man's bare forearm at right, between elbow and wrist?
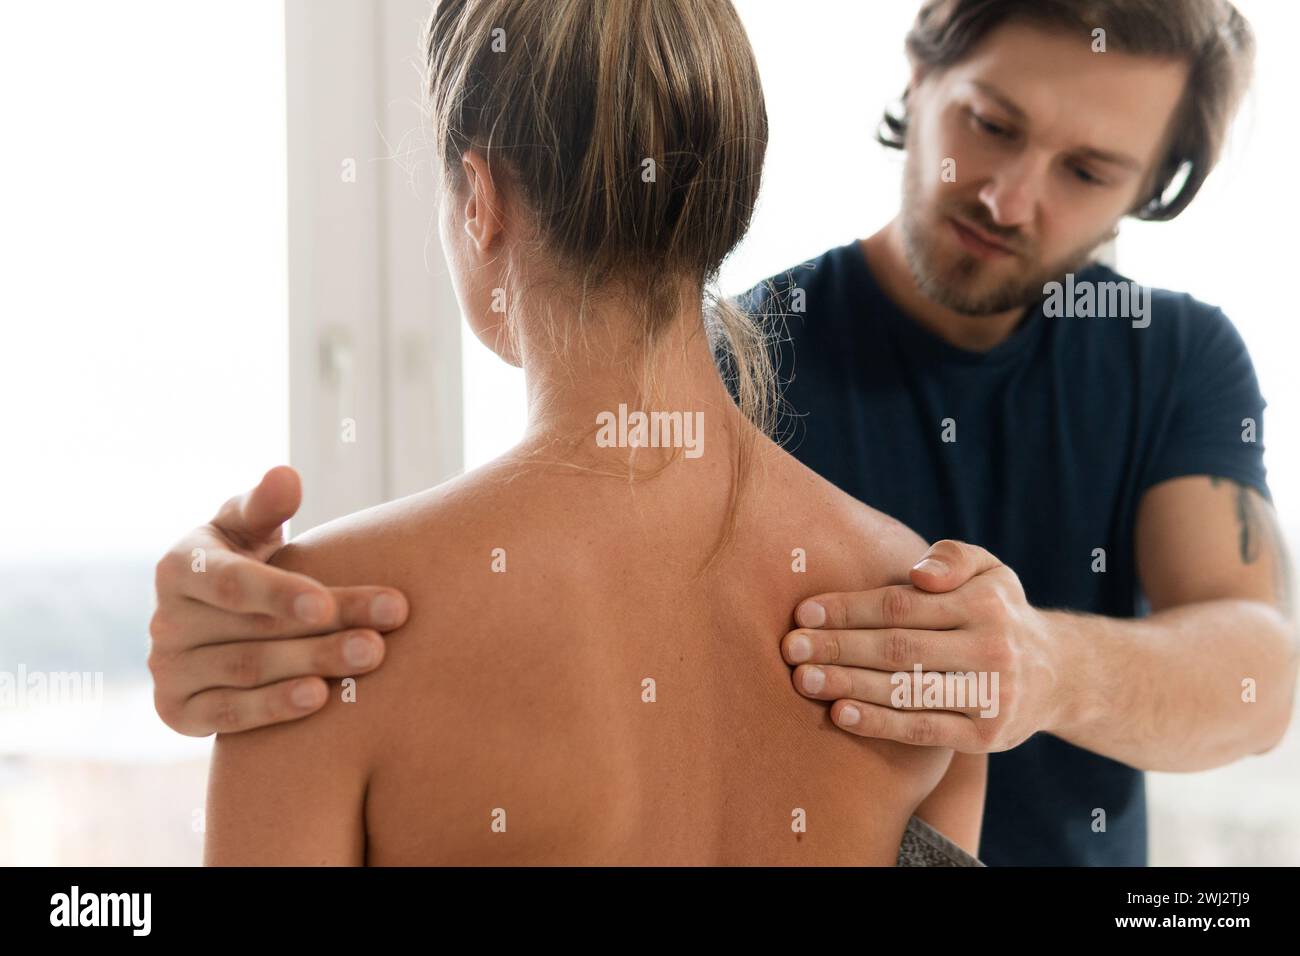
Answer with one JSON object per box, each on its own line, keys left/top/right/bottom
{"left": 1043, "top": 600, "right": 1297, "bottom": 771}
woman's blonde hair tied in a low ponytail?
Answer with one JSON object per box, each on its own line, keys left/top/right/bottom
{"left": 423, "top": 0, "right": 776, "bottom": 564}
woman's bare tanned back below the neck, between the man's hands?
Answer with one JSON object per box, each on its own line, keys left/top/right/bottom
{"left": 277, "top": 437, "right": 952, "bottom": 865}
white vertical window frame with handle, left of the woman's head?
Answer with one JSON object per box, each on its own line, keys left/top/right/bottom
{"left": 285, "top": 0, "right": 463, "bottom": 532}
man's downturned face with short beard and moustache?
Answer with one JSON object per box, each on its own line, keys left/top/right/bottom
{"left": 902, "top": 23, "right": 1187, "bottom": 315}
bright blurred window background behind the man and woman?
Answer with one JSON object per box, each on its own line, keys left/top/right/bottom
{"left": 0, "top": 0, "right": 1300, "bottom": 865}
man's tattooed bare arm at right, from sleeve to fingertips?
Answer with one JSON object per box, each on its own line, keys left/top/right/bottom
{"left": 783, "top": 476, "right": 1297, "bottom": 771}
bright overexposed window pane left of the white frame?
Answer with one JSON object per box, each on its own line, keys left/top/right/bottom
{"left": 0, "top": 0, "right": 289, "bottom": 865}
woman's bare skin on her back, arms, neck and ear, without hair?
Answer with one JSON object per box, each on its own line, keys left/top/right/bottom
{"left": 205, "top": 143, "right": 984, "bottom": 865}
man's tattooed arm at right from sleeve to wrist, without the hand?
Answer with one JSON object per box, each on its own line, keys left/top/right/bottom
{"left": 1044, "top": 476, "right": 1297, "bottom": 771}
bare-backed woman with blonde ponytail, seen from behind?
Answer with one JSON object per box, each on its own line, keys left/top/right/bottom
{"left": 205, "top": 0, "right": 983, "bottom": 865}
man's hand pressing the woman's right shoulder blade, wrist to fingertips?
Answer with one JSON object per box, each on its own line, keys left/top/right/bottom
{"left": 781, "top": 540, "right": 1063, "bottom": 753}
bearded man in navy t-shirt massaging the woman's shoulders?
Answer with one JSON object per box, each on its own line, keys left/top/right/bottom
{"left": 151, "top": 0, "right": 1296, "bottom": 865}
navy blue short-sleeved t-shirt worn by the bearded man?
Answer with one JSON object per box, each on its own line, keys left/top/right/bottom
{"left": 738, "top": 242, "right": 1271, "bottom": 866}
